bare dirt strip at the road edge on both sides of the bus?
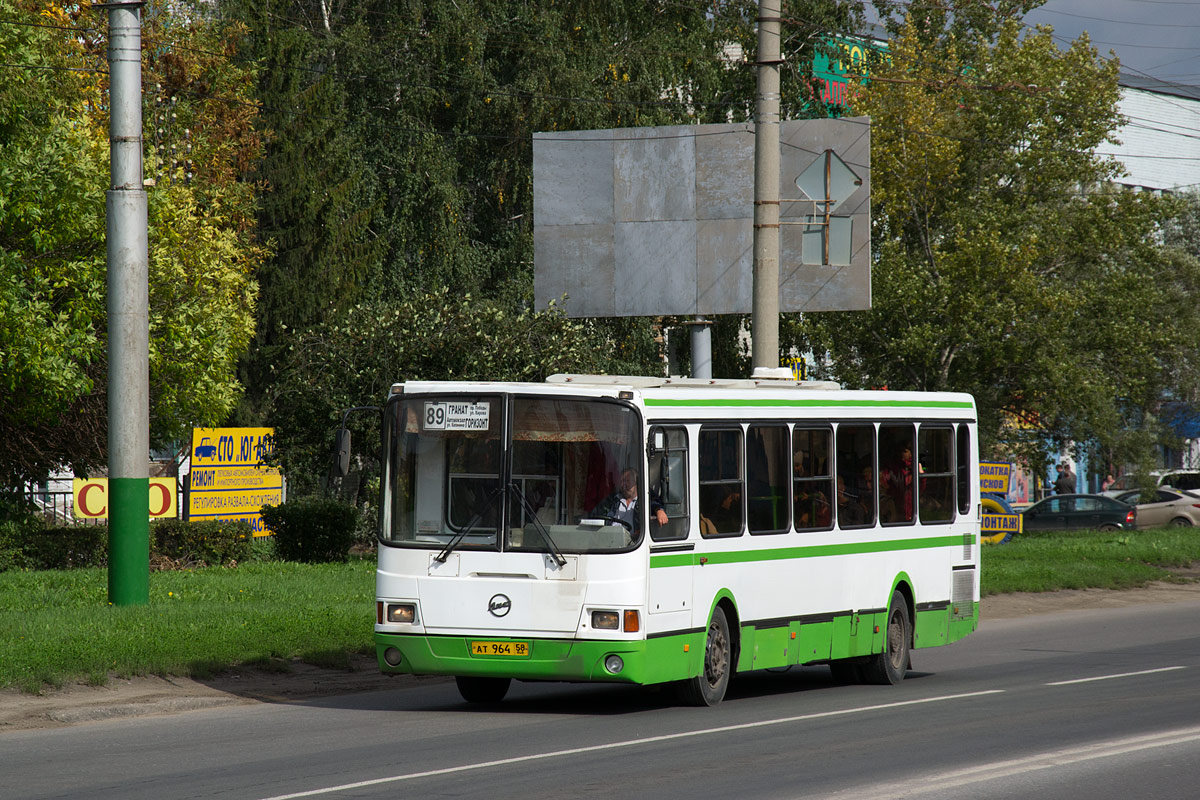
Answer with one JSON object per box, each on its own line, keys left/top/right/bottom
{"left": 7, "top": 573, "right": 1200, "bottom": 735}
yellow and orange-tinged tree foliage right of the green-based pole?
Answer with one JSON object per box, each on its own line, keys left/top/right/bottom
{"left": 143, "top": 2, "right": 270, "bottom": 445}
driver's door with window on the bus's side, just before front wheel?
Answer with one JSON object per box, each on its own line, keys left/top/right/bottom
{"left": 647, "top": 426, "right": 695, "bottom": 627}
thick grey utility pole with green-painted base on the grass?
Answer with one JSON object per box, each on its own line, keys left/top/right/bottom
{"left": 102, "top": 0, "right": 150, "bottom": 606}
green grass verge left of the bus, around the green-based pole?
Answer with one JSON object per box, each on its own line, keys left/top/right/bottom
{"left": 0, "top": 559, "right": 374, "bottom": 692}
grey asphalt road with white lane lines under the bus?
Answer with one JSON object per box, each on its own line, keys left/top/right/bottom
{"left": 0, "top": 601, "right": 1200, "bottom": 800}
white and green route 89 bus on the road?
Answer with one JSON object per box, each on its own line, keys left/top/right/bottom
{"left": 374, "top": 375, "right": 980, "bottom": 705}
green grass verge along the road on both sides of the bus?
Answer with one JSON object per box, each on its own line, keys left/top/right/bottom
{"left": 0, "top": 528, "right": 1200, "bottom": 692}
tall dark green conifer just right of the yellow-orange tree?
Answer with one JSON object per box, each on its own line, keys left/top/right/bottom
{"left": 222, "top": 0, "right": 383, "bottom": 425}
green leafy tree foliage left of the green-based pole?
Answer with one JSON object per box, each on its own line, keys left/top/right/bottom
{"left": 0, "top": 0, "right": 107, "bottom": 483}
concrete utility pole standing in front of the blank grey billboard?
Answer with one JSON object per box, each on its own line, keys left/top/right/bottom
{"left": 750, "top": 0, "right": 782, "bottom": 369}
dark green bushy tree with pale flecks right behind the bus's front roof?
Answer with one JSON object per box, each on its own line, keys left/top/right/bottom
{"left": 270, "top": 288, "right": 641, "bottom": 492}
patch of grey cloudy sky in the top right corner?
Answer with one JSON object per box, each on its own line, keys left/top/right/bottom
{"left": 1025, "top": 0, "right": 1200, "bottom": 86}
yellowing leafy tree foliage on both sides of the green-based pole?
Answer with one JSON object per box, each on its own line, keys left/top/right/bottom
{"left": 0, "top": 0, "right": 260, "bottom": 482}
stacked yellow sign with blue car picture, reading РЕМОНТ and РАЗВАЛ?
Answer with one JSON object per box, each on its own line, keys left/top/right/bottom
{"left": 187, "top": 428, "right": 283, "bottom": 536}
